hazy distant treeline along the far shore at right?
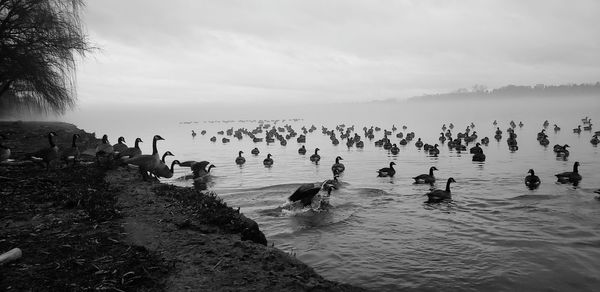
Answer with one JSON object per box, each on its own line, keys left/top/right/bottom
{"left": 411, "top": 82, "right": 600, "bottom": 100}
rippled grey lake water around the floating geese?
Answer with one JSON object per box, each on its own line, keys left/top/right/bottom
{"left": 67, "top": 98, "right": 600, "bottom": 291}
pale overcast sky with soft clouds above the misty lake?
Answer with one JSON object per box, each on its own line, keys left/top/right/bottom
{"left": 77, "top": 0, "right": 600, "bottom": 106}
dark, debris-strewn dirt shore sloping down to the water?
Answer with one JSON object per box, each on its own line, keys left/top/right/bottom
{"left": 0, "top": 122, "right": 364, "bottom": 291}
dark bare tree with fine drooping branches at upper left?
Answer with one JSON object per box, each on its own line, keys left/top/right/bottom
{"left": 0, "top": 0, "right": 91, "bottom": 116}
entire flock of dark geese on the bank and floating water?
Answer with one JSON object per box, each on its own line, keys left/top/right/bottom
{"left": 0, "top": 117, "right": 600, "bottom": 206}
